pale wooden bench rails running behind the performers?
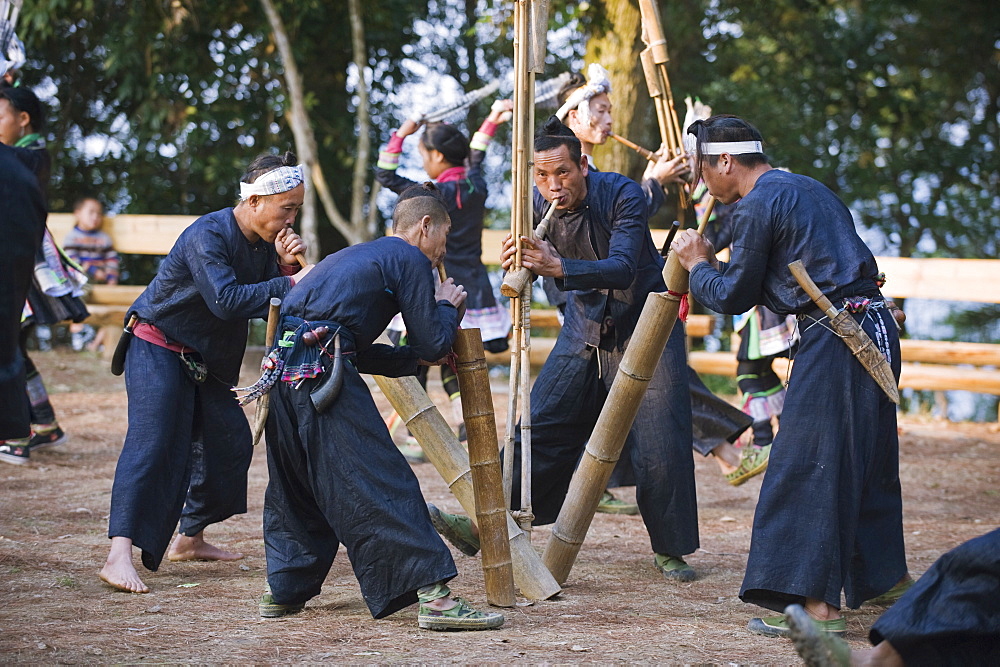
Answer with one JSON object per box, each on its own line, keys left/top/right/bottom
{"left": 49, "top": 213, "right": 1000, "bottom": 404}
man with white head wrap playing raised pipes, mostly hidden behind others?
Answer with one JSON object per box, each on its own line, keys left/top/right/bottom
{"left": 543, "top": 68, "right": 752, "bottom": 498}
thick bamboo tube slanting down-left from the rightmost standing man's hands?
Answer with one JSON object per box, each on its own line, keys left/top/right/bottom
{"left": 542, "top": 200, "right": 711, "bottom": 584}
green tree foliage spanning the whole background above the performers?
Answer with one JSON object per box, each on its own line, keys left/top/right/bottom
{"left": 18, "top": 0, "right": 1000, "bottom": 257}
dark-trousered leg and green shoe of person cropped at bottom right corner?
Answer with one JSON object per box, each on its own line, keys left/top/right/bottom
{"left": 785, "top": 530, "right": 1000, "bottom": 667}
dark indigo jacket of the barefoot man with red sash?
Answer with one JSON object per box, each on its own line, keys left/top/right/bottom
{"left": 129, "top": 208, "right": 292, "bottom": 386}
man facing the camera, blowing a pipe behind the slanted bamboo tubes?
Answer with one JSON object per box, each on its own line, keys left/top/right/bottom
{"left": 431, "top": 117, "right": 698, "bottom": 581}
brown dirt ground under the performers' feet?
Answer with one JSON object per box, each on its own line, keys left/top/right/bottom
{"left": 0, "top": 351, "right": 1000, "bottom": 664}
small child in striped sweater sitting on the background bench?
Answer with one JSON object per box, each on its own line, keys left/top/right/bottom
{"left": 63, "top": 197, "right": 119, "bottom": 352}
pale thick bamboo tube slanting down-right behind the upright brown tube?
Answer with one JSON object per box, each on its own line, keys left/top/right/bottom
{"left": 375, "top": 375, "right": 561, "bottom": 600}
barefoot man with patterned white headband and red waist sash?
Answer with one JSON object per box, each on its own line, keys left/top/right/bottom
{"left": 100, "top": 153, "right": 311, "bottom": 593}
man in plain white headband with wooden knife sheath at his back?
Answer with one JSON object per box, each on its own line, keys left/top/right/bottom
{"left": 671, "top": 116, "right": 912, "bottom": 636}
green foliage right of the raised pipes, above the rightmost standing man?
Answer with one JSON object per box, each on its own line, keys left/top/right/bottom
{"left": 705, "top": 0, "right": 1000, "bottom": 257}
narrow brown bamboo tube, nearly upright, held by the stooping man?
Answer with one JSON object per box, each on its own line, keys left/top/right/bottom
{"left": 455, "top": 329, "right": 514, "bottom": 607}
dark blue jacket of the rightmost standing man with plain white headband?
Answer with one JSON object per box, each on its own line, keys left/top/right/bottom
{"left": 691, "top": 169, "right": 878, "bottom": 315}
